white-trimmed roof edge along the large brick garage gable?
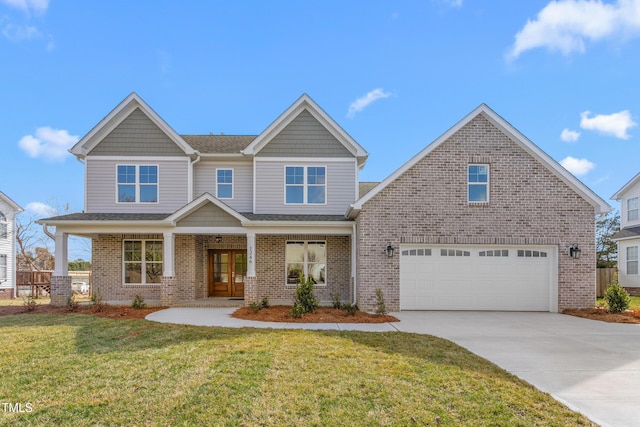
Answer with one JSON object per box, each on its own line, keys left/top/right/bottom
{"left": 348, "top": 104, "right": 611, "bottom": 216}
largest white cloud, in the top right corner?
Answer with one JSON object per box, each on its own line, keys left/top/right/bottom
{"left": 507, "top": 0, "right": 640, "bottom": 60}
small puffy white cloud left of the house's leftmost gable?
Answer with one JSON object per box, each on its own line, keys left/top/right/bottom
{"left": 18, "top": 126, "right": 79, "bottom": 161}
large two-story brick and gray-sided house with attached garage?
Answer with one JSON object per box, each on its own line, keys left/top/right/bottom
{"left": 41, "top": 93, "right": 610, "bottom": 311}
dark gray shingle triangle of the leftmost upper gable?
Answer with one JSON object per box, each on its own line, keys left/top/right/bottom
{"left": 89, "top": 108, "right": 184, "bottom": 156}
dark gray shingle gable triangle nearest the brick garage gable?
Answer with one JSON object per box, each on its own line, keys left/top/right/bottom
{"left": 256, "top": 110, "right": 353, "bottom": 157}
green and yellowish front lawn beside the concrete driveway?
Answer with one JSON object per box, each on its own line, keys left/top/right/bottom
{"left": 0, "top": 314, "right": 592, "bottom": 426}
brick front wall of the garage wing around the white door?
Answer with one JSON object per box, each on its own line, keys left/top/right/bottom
{"left": 356, "top": 116, "right": 595, "bottom": 311}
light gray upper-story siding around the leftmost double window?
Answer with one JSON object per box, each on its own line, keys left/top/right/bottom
{"left": 85, "top": 157, "right": 189, "bottom": 213}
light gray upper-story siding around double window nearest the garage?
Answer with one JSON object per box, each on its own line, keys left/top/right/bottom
{"left": 255, "top": 158, "right": 358, "bottom": 215}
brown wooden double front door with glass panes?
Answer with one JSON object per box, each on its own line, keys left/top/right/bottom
{"left": 209, "top": 249, "right": 247, "bottom": 298}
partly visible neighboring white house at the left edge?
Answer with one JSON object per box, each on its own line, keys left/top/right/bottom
{"left": 0, "top": 191, "right": 23, "bottom": 299}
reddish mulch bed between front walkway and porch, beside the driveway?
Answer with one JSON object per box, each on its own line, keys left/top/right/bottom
{"left": 231, "top": 305, "right": 399, "bottom": 323}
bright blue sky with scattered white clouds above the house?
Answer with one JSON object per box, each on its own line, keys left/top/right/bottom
{"left": 0, "top": 0, "right": 640, "bottom": 259}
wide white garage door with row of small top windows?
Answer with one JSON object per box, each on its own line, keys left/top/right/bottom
{"left": 400, "top": 245, "right": 557, "bottom": 311}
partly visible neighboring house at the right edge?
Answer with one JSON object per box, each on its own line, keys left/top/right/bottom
{"left": 611, "top": 173, "right": 640, "bottom": 296}
